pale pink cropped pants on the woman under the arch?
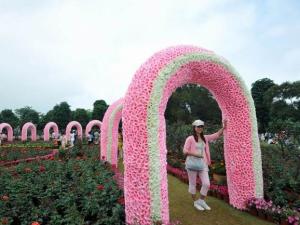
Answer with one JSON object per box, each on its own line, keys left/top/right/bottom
{"left": 187, "top": 170, "right": 210, "bottom": 196}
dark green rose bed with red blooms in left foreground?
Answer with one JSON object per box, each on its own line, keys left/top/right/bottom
{"left": 0, "top": 145, "right": 125, "bottom": 225}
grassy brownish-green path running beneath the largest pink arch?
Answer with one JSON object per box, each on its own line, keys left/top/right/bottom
{"left": 118, "top": 162, "right": 272, "bottom": 225}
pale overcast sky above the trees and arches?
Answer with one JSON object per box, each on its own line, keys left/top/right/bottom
{"left": 0, "top": 0, "right": 300, "bottom": 113}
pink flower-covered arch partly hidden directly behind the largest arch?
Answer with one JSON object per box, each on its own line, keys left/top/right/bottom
{"left": 100, "top": 98, "right": 123, "bottom": 166}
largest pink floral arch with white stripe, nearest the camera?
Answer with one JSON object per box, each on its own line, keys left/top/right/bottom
{"left": 122, "top": 46, "right": 263, "bottom": 224}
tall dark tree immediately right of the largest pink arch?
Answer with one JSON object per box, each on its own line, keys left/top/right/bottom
{"left": 251, "top": 78, "right": 275, "bottom": 133}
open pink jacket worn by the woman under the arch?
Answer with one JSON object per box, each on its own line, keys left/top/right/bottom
{"left": 183, "top": 132, "right": 222, "bottom": 165}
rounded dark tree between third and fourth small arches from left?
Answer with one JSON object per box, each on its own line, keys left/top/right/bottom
{"left": 51, "top": 102, "right": 72, "bottom": 130}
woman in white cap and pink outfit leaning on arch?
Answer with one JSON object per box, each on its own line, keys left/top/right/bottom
{"left": 183, "top": 120, "right": 226, "bottom": 210}
